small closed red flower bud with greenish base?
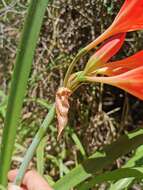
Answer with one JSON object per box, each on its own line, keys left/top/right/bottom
{"left": 85, "top": 33, "right": 126, "bottom": 73}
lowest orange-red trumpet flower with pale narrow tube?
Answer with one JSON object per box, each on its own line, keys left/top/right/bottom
{"left": 86, "top": 66, "right": 143, "bottom": 100}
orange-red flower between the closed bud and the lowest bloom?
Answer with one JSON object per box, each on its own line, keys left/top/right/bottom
{"left": 97, "top": 51, "right": 143, "bottom": 76}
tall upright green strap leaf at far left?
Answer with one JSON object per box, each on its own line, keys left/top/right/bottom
{"left": 0, "top": 0, "right": 48, "bottom": 186}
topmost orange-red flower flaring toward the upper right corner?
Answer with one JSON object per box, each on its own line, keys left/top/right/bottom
{"left": 84, "top": 0, "right": 143, "bottom": 51}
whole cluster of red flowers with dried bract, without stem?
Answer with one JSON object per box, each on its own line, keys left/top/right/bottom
{"left": 56, "top": 0, "right": 143, "bottom": 137}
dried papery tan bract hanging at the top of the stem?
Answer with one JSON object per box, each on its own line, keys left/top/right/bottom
{"left": 55, "top": 87, "right": 72, "bottom": 139}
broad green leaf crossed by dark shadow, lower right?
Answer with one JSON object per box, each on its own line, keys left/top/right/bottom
{"left": 53, "top": 129, "right": 143, "bottom": 190}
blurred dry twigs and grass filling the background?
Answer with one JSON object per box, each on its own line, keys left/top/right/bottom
{"left": 0, "top": 0, "right": 143, "bottom": 190}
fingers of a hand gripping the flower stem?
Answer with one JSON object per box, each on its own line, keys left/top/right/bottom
{"left": 8, "top": 170, "right": 53, "bottom": 190}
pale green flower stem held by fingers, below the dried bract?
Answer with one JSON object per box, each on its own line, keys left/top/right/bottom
{"left": 14, "top": 104, "right": 55, "bottom": 185}
